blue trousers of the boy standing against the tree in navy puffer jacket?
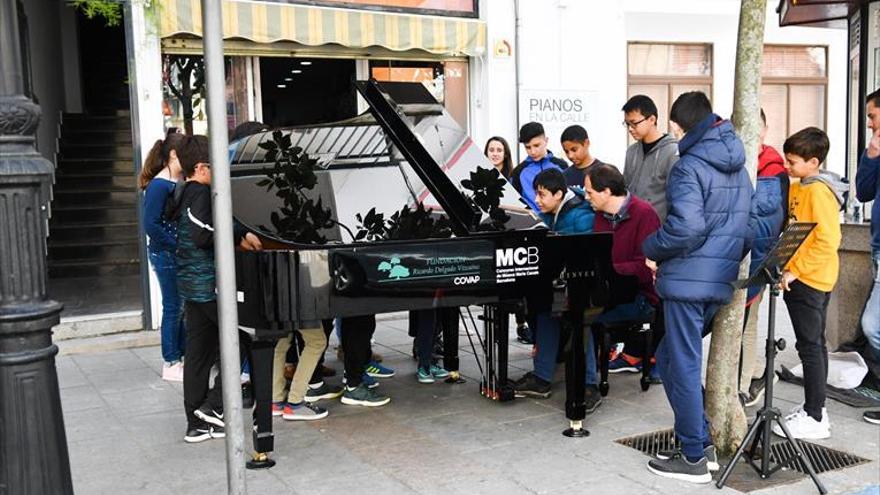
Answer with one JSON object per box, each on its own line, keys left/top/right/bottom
{"left": 655, "top": 300, "right": 721, "bottom": 459}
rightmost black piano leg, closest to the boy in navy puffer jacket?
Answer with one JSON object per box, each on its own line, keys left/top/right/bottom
{"left": 562, "top": 308, "right": 590, "bottom": 438}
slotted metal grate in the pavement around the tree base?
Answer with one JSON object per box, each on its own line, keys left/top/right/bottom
{"left": 615, "top": 429, "right": 870, "bottom": 474}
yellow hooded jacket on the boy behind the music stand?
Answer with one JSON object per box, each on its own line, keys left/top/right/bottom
{"left": 785, "top": 170, "right": 847, "bottom": 292}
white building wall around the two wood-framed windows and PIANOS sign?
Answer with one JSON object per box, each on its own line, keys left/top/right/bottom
{"left": 471, "top": 0, "right": 847, "bottom": 173}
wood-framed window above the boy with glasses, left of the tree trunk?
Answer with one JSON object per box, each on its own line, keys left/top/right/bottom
{"left": 627, "top": 42, "right": 712, "bottom": 139}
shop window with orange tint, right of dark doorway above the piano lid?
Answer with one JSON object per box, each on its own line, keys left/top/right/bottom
{"left": 370, "top": 60, "right": 468, "bottom": 131}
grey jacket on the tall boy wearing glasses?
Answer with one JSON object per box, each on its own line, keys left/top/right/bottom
{"left": 623, "top": 134, "right": 678, "bottom": 222}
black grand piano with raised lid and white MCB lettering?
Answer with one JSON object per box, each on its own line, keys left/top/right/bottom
{"left": 231, "top": 80, "right": 613, "bottom": 467}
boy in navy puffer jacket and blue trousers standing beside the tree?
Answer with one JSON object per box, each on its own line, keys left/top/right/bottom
{"left": 642, "top": 91, "right": 752, "bottom": 483}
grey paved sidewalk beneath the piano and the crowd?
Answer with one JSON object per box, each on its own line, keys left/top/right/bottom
{"left": 57, "top": 302, "right": 880, "bottom": 495}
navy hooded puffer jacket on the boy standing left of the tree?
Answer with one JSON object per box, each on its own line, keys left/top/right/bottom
{"left": 642, "top": 114, "right": 752, "bottom": 303}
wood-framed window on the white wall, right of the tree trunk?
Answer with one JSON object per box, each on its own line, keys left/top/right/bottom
{"left": 761, "top": 45, "right": 828, "bottom": 152}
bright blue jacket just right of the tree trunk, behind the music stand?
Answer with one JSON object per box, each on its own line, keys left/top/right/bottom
{"left": 746, "top": 177, "right": 788, "bottom": 305}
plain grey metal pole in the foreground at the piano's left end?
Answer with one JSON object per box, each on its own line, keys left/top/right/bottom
{"left": 202, "top": 0, "right": 247, "bottom": 495}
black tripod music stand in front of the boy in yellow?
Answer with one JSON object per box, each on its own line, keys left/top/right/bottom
{"left": 715, "top": 222, "right": 827, "bottom": 495}
